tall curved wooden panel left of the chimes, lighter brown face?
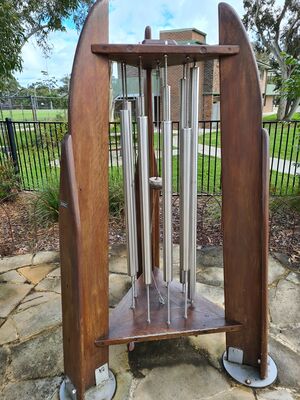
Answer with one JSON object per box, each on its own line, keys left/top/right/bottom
{"left": 60, "top": 0, "right": 109, "bottom": 391}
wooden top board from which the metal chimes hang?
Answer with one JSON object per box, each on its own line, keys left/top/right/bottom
{"left": 92, "top": 43, "right": 240, "bottom": 69}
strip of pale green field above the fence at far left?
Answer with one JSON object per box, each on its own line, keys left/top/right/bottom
{"left": 0, "top": 109, "right": 68, "bottom": 121}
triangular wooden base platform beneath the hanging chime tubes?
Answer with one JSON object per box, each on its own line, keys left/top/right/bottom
{"left": 95, "top": 268, "right": 242, "bottom": 346}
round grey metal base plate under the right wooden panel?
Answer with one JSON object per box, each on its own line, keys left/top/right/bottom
{"left": 223, "top": 351, "right": 277, "bottom": 388}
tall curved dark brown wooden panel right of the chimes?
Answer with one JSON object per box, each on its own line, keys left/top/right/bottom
{"left": 219, "top": 3, "right": 267, "bottom": 374}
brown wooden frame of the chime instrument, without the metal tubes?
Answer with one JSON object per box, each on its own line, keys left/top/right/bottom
{"left": 59, "top": 0, "right": 268, "bottom": 400}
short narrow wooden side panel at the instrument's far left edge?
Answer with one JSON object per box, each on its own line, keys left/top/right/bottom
{"left": 59, "top": 135, "right": 83, "bottom": 394}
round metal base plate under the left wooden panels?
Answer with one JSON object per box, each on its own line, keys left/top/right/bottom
{"left": 59, "top": 370, "right": 116, "bottom": 400}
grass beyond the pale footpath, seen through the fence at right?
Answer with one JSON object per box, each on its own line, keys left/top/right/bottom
{"left": 199, "top": 121, "right": 300, "bottom": 161}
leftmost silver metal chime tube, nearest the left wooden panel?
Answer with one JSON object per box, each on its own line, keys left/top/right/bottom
{"left": 120, "top": 64, "right": 138, "bottom": 308}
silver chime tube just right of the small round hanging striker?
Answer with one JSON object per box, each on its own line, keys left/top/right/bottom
{"left": 162, "top": 56, "right": 173, "bottom": 325}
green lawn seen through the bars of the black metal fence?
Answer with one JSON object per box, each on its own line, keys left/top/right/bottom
{"left": 0, "top": 116, "right": 300, "bottom": 195}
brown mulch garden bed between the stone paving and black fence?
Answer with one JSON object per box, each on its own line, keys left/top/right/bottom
{"left": 0, "top": 193, "right": 300, "bottom": 269}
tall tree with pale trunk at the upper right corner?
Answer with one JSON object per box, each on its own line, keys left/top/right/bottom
{"left": 243, "top": 0, "right": 300, "bottom": 120}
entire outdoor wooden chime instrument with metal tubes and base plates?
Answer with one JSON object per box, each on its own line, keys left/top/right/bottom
{"left": 60, "top": 0, "right": 276, "bottom": 400}
